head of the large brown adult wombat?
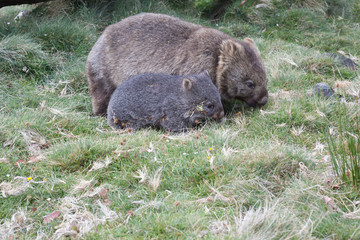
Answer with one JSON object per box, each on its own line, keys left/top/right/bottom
{"left": 216, "top": 38, "right": 268, "bottom": 107}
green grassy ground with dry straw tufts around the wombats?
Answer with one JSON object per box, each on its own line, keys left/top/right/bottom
{"left": 0, "top": 0, "right": 360, "bottom": 239}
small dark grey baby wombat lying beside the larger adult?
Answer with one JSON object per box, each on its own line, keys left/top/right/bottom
{"left": 107, "top": 72, "right": 224, "bottom": 132}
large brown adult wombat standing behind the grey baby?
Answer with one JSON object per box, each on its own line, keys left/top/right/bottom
{"left": 86, "top": 13, "right": 268, "bottom": 115}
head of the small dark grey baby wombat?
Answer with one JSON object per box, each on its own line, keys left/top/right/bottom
{"left": 182, "top": 72, "right": 224, "bottom": 127}
